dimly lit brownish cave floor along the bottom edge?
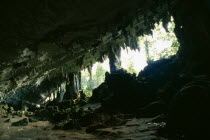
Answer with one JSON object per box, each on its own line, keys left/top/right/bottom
{"left": 0, "top": 106, "right": 165, "bottom": 140}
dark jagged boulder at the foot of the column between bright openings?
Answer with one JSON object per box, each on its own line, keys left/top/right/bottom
{"left": 90, "top": 69, "right": 149, "bottom": 112}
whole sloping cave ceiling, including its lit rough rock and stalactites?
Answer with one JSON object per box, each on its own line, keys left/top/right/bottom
{"left": 0, "top": 0, "right": 174, "bottom": 105}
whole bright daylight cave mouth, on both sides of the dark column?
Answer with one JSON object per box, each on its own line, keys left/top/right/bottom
{"left": 82, "top": 18, "right": 179, "bottom": 96}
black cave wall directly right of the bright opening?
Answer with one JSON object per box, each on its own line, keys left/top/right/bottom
{"left": 171, "top": 0, "right": 210, "bottom": 74}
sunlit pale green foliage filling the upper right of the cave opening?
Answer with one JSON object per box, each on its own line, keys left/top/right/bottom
{"left": 139, "top": 18, "right": 180, "bottom": 63}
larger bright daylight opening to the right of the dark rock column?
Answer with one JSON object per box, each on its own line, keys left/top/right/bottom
{"left": 121, "top": 18, "right": 179, "bottom": 74}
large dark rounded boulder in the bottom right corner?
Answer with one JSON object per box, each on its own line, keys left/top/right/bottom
{"left": 166, "top": 80, "right": 210, "bottom": 139}
